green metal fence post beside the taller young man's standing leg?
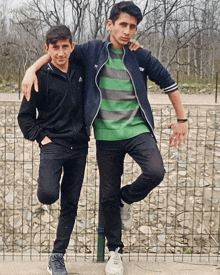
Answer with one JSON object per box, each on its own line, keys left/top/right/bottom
{"left": 97, "top": 191, "right": 105, "bottom": 262}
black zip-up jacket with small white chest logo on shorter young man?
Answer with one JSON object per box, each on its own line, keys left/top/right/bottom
{"left": 18, "top": 62, "right": 89, "bottom": 148}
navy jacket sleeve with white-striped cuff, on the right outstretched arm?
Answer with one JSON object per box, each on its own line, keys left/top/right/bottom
{"left": 139, "top": 50, "right": 178, "bottom": 93}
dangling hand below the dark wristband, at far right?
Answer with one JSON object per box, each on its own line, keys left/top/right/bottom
{"left": 168, "top": 122, "right": 188, "bottom": 147}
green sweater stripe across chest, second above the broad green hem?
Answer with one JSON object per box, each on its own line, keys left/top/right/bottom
{"left": 99, "top": 76, "right": 133, "bottom": 92}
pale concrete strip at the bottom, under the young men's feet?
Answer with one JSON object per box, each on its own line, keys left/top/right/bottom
{"left": 0, "top": 261, "right": 220, "bottom": 275}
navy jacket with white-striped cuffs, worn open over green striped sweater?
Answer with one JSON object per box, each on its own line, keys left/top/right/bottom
{"left": 70, "top": 40, "right": 177, "bottom": 138}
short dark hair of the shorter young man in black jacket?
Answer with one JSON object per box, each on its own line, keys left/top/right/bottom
{"left": 46, "top": 25, "right": 72, "bottom": 46}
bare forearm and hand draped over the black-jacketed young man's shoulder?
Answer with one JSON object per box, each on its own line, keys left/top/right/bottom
{"left": 21, "top": 54, "right": 51, "bottom": 101}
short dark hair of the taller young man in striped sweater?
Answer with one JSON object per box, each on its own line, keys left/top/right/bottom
{"left": 109, "top": 1, "right": 143, "bottom": 24}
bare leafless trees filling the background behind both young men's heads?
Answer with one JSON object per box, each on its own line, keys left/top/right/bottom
{"left": 0, "top": 0, "right": 220, "bottom": 82}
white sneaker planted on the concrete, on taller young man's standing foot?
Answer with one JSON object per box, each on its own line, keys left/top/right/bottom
{"left": 105, "top": 247, "right": 123, "bottom": 275}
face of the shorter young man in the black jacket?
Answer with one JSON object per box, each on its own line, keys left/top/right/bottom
{"left": 44, "top": 39, "right": 75, "bottom": 72}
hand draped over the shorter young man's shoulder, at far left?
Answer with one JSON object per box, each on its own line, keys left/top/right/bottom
{"left": 21, "top": 68, "right": 38, "bottom": 101}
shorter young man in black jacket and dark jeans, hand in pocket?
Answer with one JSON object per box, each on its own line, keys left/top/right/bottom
{"left": 18, "top": 25, "right": 89, "bottom": 275}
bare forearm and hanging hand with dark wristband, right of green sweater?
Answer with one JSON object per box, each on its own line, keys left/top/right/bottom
{"left": 168, "top": 90, "right": 188, "bottom": 146}
